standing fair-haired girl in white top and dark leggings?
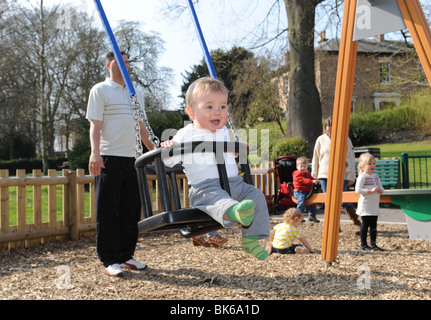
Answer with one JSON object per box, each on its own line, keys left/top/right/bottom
{"left": 355, "top": 153, "right": 384, "bottom": 251}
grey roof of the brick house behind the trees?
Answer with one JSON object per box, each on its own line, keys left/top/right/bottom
{"left": 316, "top": 38, "right": 414, "bottom": 54}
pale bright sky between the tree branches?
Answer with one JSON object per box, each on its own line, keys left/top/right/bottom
{"left": 85, "top": 0, "right": 286, "bottom": 107}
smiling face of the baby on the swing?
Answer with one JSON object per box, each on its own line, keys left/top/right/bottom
{"left": 187, "top": 92, "right": 228, "bottom": 132}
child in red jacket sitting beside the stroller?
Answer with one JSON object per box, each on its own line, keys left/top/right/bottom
{"left": 292, "top": 157, "right": 320, "bottom": 222}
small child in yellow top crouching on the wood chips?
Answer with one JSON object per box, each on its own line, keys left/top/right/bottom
{"left": 266, "top": 208, "right": 314, "bottom": 254}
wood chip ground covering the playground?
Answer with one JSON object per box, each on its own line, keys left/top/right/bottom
{"left": 0, "top": 221, "right": 431, "bottom": 300}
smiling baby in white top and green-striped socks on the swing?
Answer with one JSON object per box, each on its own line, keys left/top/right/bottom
{"left": 161, "top": 77, "right": 269, "bottom": 260}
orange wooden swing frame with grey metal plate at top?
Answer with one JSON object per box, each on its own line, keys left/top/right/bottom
{"left": 322, "top": 0, "right": 431, "bottom": 265}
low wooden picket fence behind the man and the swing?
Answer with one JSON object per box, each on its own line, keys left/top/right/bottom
{"left": 0, "top": 164, "right": 274, "bottom": 249}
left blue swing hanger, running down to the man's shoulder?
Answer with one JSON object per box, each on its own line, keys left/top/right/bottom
{"left": 94, "top": 0, "right": 136, "bottom": 97}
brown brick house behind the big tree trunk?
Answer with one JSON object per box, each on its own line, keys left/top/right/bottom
{"left": 278, "top": 33, "right": 429, "bottom": 118}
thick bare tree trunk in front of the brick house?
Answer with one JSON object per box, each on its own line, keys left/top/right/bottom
{"left": 285, "top": 0, "right": 322, "bottom": 152}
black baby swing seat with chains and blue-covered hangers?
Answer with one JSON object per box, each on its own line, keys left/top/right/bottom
{"left": 94, "top": 0, "right": 252, "bottom": 238}
